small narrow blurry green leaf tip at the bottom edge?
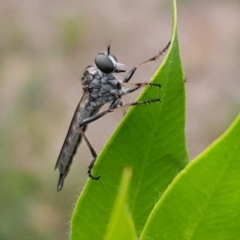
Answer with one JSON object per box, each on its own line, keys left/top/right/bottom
{"left": 104, "top": 168, "right": 137, "bottom": 240}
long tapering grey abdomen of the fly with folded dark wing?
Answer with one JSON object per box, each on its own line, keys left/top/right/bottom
{"left": 55, "top": 94, "right": 90, "bottom": 191}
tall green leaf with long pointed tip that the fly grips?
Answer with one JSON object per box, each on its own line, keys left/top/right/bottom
{"left": 71, "top": 1, "right": 188, "bottom": 240}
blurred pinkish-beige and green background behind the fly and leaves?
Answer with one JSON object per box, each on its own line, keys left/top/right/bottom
{"left": 0, "top": 0, "right": 240, "bottom": 240}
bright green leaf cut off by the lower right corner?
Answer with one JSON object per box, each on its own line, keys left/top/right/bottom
{"left": 141, "top": 115, "right": 240, "bottom": 240}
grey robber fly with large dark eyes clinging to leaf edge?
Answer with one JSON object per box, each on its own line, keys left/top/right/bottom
{"left": 55, "top": 42, "right": 170, "bottom": 192}
